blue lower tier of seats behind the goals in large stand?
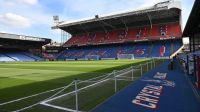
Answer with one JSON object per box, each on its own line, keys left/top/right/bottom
{"left": 58, "top": 40, "right": 182, "bottom": 60}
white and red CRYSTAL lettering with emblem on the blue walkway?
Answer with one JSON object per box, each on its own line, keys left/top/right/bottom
{"left": 132, "top": 72, "right": 175, "bottom": 109}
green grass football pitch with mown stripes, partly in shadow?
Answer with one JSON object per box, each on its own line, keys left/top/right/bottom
{"left": 0, "top": 59, "right": 162, "bottom": 112}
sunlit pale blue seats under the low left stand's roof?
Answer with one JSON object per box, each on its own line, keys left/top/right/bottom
{"left": 0, "top": 52, "right": 43, "bottom": 62}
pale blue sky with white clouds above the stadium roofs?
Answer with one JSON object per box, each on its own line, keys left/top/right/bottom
{"left": 0, "top": 0, "right": 194, "bottom": 42}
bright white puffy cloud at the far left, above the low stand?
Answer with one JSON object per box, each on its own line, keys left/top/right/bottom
{"left": 0, "top": 13, "right": 31, "bottom": 28}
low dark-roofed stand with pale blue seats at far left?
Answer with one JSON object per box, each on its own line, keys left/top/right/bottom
{"left": 0, "top": 33, "right": 51, "bottom": 62}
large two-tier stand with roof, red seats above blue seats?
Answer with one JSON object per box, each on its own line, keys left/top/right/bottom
{"left": 54, "top": 1, "right": 183, "bottom": 60}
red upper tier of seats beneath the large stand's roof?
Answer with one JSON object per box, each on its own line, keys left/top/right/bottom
{"left": 64, "top": 22, "right": 182, "bottom": 47}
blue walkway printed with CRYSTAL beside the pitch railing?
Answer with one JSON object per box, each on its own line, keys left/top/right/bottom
{"left": 92, "top": 61, "right": 200, "bottom": 112}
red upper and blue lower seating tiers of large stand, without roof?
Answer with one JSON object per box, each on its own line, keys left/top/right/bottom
{"left": 57, "top": 23, "right": 182, "bottom": 60}
